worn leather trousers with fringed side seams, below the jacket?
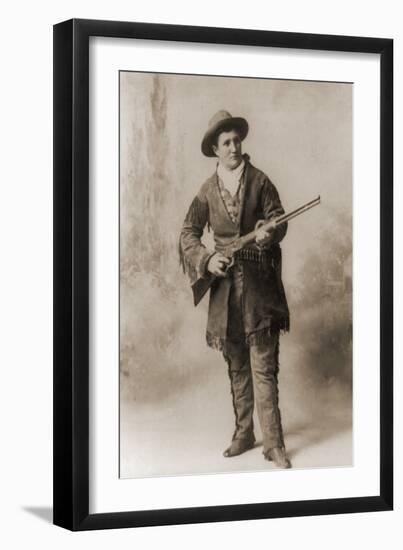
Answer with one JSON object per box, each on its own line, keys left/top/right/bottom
{"left": 224, "top": 262, "right": 284, "bottom": 453}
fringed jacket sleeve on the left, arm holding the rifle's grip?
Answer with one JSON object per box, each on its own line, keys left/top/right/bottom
{"left": 179, "top": 195, "right": 215, "bottom": 284}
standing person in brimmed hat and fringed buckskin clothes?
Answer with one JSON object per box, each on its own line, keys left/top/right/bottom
{"left": 179, "top": 111, "right": 291, "bottom": 468}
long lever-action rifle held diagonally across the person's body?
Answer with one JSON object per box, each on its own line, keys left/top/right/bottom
{"left": 192, "top": 195, "right": 320, "bottom": 306}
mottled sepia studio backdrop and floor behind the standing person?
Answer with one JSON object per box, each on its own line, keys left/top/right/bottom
{"left": 120, "top": 72, "right": 352, "bottom": 477}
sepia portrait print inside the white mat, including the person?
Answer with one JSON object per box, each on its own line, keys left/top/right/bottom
{"left": 119, "top": 71, "right": 354, "bottom": 479}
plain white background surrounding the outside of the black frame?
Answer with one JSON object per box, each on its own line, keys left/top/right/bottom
{"left": 0, "top": 0, "right": 403, "bottom": 550}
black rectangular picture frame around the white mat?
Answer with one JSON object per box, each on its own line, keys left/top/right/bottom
{"left": 54, "top": 19, "right": 393, "bottom": 530}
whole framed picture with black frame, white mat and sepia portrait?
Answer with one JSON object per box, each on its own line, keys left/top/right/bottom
{"left": 54, "top": 19, "right": 393, "bottom": 530}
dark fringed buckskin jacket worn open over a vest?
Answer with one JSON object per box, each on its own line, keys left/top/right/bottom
{"left": 179, "top": 155, "right": 290, "bottom": 350}
